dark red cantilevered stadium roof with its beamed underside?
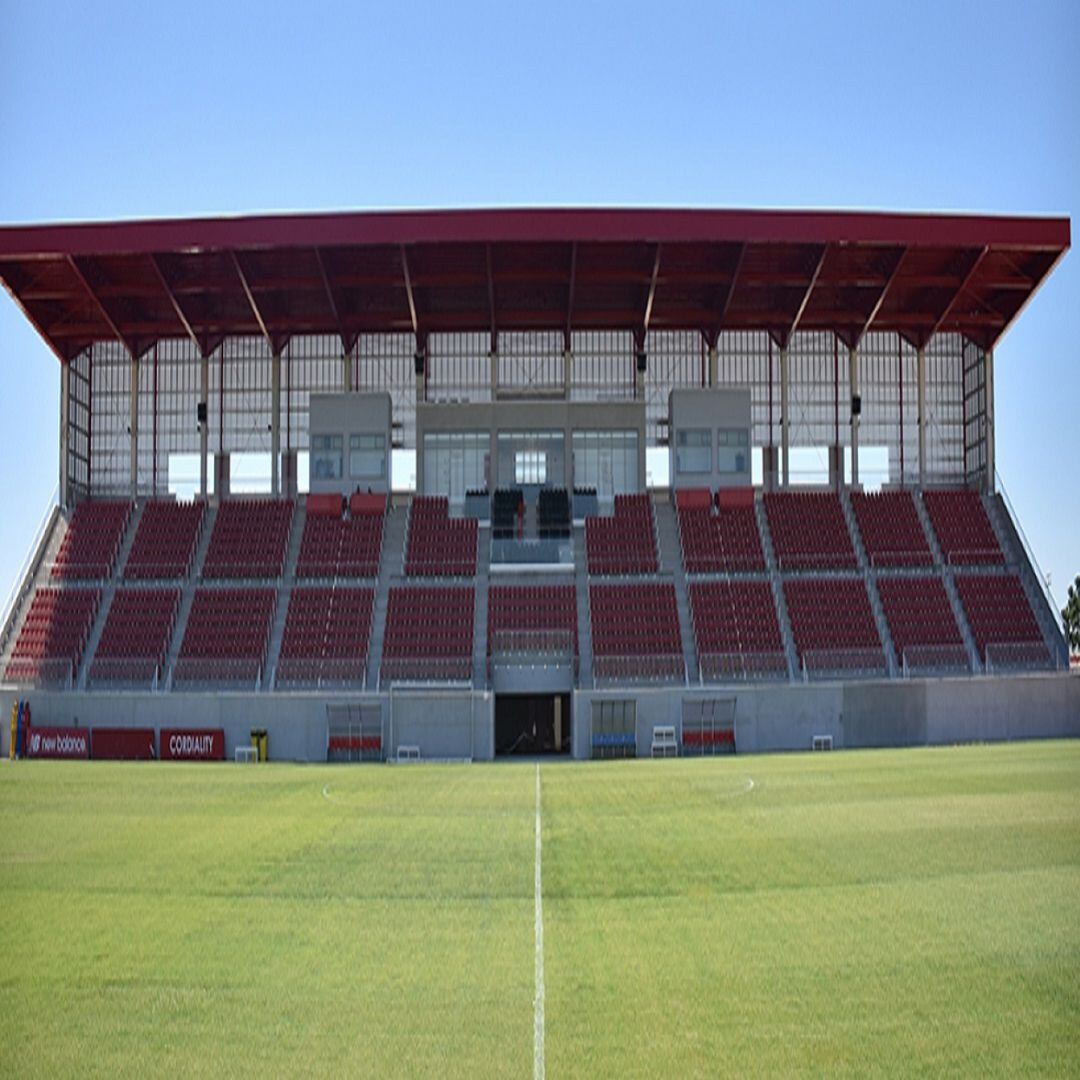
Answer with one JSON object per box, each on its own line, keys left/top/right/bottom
{"left": 0, "top": 210, "right": 1069, "bottom": 361}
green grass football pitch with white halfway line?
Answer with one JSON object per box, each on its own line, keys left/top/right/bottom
{"left": 0, "top": 742, "right": 1080, "bottom": 1077}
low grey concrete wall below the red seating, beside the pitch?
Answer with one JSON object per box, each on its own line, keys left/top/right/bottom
{"left": 0, "top": 674, "right": 1080, "bottom": 761}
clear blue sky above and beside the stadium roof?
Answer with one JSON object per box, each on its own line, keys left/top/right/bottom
{"left": 0, "top": 0, "right": 1080, "bottom": 602}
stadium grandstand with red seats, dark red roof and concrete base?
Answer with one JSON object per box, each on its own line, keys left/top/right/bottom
{"left": 0, "top": 210, "right": 1080, "bottom": 760}
